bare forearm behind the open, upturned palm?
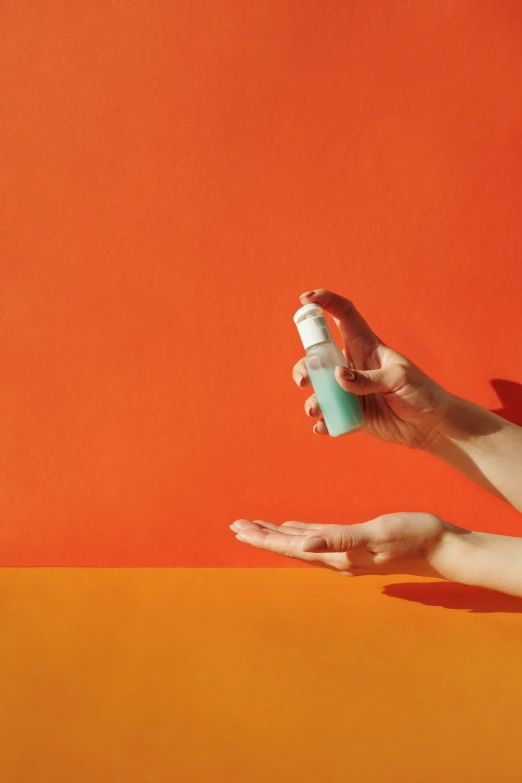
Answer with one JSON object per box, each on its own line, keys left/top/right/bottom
{"left": 432, "top": 531, "right": 522, "bottom": 598}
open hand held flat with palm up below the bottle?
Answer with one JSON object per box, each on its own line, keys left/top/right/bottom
{"left": 230, "top": 513, "right": 466, "bottom": 579}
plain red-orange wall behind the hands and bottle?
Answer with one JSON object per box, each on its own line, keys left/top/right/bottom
{"left": 0, "top": 0, "right": 522, "bottom": 566}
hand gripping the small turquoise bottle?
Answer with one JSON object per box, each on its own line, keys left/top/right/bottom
{"left": 292, "top": 288, "right": 452, "bottom": 448}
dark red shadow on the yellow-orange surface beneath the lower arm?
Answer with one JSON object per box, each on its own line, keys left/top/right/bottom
{"left": 383, "top": 582, "right": 522, "bottom": 614}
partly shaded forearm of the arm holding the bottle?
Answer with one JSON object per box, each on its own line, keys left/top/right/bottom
{"left": 426, "top": 397, "right": 522, "bottom": 511}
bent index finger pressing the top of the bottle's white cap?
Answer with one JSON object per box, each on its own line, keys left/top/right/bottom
{"left": 300, "top": 288, "right": 381, "bottom": 362}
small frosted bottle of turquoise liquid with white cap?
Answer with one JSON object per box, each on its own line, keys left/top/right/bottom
{"left": 294, "top": 304, "right": 365, "bottom": 438}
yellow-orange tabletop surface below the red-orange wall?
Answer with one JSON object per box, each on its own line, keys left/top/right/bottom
{"left": 0, "top": 569, "right": 522, "bottom": 783}
